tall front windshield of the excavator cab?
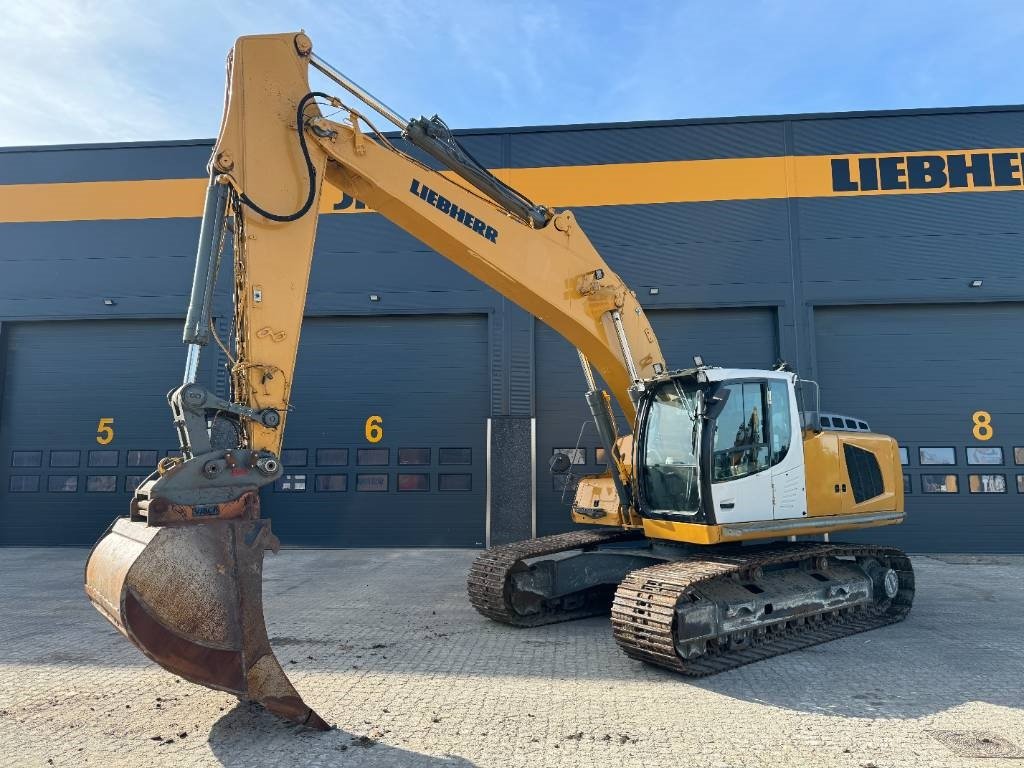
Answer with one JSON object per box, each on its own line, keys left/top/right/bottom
{"left": 643, "top": 380, "right": 702, "bottom": 514}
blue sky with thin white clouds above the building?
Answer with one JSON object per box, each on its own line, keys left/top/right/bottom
{"left": 0, "top": 0, "right": 1024, "bottom": 145}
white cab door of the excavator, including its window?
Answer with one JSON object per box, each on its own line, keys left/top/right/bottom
{"left": 711, "top": 381, "right": 774, "bottom": 523}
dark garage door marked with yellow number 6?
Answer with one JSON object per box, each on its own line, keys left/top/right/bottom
{"left": 263, "top": 315, "right": 489, "bottom": 547}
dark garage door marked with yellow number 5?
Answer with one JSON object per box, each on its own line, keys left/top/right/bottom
{"left": 0, "top": 319, "right": 214, "bottom": 546}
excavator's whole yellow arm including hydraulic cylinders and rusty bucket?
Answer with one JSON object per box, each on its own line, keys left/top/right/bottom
{"left": 85, "top": 33, "right": 665, "bottom": 728}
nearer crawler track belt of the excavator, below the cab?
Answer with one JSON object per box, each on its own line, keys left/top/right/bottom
{"left": 611, "top": 543, "right": 914, "bottom": 677}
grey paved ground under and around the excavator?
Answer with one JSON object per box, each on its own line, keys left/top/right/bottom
{"left": 0, "top": 549, "right": 1024, "bottom": 768}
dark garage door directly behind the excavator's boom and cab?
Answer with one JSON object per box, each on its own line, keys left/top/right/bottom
{"left": 537, "top": 308, "right": 778, "bottom": 536}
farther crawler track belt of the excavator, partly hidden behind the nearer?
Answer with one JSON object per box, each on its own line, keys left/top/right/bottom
{"left": 466, "top": 528, "right": 642, "bottom": 627}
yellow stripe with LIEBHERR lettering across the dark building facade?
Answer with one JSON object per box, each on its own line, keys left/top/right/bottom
{"left": 0, "top": 148, "right": 1024, "bottom": 223}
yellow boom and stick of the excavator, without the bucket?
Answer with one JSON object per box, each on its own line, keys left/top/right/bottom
{"left": 215, "top": 33, "right": 665, "bottom": 453}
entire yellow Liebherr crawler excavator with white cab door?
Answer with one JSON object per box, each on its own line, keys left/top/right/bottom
{"left": 85, "top": 32, "right": 913, "bottom": 728}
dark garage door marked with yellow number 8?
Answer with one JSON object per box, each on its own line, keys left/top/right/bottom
{"left": 814, "top": 303, "right": 1024, "bottom": 552}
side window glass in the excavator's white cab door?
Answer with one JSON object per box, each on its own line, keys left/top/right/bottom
{"left": 712, "top": 382, "right": 769, "bottom": 482}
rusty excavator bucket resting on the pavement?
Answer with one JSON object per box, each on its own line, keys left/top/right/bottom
{"left": 85, "top": 517, "right": 329, "bottom": 730}
